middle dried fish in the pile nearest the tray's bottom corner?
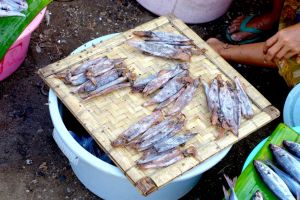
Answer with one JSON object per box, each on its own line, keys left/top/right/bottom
{"left": 135, "top": 118, "right": 184, "bottom": 151}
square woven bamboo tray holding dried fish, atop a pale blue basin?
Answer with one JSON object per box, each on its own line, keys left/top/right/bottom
{"left": 39, "top": 16, "right": 279, "bottom": 196}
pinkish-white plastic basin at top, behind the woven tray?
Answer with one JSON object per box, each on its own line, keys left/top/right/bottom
{"left": 137, "top": 0, "right": 232, "bottom": 24}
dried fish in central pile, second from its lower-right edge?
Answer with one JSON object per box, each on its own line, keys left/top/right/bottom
{"left": 143, "top": 77, "right": 191, "bottom": 107}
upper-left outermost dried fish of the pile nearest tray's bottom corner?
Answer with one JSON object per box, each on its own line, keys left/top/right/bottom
{"left": 112, "top": 111, "right": 163, "bottom": 147}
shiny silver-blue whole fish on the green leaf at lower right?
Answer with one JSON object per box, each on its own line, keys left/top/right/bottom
{"left": 254, "top": 140, "right": 300, "bottom": 200}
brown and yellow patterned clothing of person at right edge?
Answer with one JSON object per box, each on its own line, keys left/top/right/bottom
{"left": 276, "top": 0, "right": 300, "bottom": 87}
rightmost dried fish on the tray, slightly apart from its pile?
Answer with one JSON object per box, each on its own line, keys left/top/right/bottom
{"left": 234, "top": 77, "right": 254, "bottom": 119}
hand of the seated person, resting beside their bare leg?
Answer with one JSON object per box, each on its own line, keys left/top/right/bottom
{"left": 263, "top": 24, "right": 300, "bottom": 62}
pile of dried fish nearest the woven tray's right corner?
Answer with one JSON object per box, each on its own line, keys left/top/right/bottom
{"left": 201, "top": 75, "right": 253, "bottom": 137}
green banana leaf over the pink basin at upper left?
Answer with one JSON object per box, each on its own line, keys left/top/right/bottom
{"left": 0, "top": 0, "right": 52, "bottom": 60}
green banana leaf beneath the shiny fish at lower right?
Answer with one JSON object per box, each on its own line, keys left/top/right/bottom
{"left": 235, "top": 124, "right": 300, "bottom": 200}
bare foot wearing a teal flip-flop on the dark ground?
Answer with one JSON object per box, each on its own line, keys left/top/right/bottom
{"left": 228, "top": 14, "right": 278, "bottom": 42}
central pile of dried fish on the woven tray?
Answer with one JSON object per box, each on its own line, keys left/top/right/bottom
{"left": 132, "top": 64, "right": 199, "bottom": 115}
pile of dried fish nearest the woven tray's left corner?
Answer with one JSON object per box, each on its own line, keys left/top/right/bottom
{"left": 56, "top": 56, "right": 135, "bottom": 100}
